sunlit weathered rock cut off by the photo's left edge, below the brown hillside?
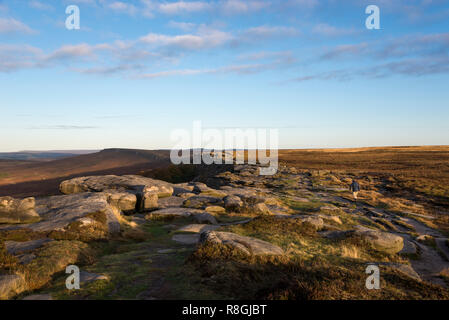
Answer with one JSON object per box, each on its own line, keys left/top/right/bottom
{"left": 0, "top": 197, "right": 40, "bottom": 224}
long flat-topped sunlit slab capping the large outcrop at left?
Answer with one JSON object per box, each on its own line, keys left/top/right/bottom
{"left": 59, "top": 175, "right": 173, "bottom": 198}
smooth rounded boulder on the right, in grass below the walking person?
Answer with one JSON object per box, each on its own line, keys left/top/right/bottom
{"left": 354, "top": 226, "right": 404, "bottom": 254}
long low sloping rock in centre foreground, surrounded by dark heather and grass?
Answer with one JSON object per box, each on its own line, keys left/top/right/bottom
{"left": 200, "top": 231, "right": 284, "bottom": 255}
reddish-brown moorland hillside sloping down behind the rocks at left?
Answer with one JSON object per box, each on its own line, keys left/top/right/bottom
{"left": 0, "top": 149, "right": 170, "bottom": 196}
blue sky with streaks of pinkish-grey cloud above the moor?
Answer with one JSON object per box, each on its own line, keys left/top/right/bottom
{"left": 0, "top": 0, "right": 449, "bottom": 152}
